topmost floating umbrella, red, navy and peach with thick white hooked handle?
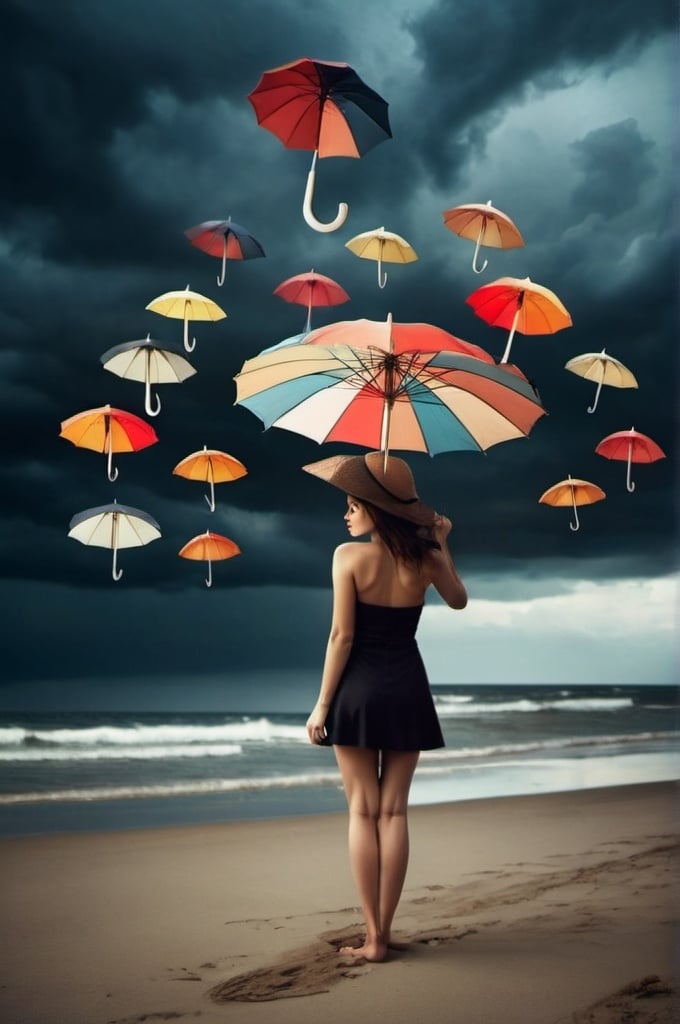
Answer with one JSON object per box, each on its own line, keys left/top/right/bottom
{"left": 248, "top": 57, "right": 392, "bottom": 231}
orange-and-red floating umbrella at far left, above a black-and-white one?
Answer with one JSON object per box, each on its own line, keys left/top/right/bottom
{"left": 59, "top": 406, "right": 158, "bottom": 483}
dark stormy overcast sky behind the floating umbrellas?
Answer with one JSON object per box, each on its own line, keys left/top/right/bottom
{"left": 0, "top": 0, "right": 679, "bottom": 710}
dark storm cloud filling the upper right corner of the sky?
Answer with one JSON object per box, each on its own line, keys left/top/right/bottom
{"left": 403, "top": 0, "right": 677, "bottom": 182}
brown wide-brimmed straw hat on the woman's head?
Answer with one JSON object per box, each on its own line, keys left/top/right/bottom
{"left": 302, "top": 452, "right": 436, "bottom": 526}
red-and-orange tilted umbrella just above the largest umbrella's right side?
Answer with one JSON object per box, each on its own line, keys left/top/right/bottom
{"left": 465, "top": 278, "right": 571, "bottom": 362}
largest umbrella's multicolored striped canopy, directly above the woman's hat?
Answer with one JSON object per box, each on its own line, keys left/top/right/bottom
{"left": 235, "top": 335, "right": 544, "bottom": 458}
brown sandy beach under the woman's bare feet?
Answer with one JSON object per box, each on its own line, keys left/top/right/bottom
{"left": 0, "top": 783, "right": 680, "bottom": 1024}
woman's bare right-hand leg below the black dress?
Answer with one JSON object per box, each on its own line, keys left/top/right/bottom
{"left": 378, "top": 751, "right": 419, "bottom": 945}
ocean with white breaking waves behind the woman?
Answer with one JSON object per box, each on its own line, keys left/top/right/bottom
{"left": 0, "top": 685, "right": 680, "bottom": 836}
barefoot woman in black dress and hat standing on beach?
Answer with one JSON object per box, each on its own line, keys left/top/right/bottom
{"left": 303, "top": 452, "right": 467, "bottom": 962}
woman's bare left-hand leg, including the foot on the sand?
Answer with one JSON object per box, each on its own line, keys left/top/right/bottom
{"left": 334, "top": 746, "right": 387, "bottom": 961}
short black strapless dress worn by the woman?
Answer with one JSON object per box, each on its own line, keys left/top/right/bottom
{"left": 324, "top": 601, "right": 444, "bottom": 751}
